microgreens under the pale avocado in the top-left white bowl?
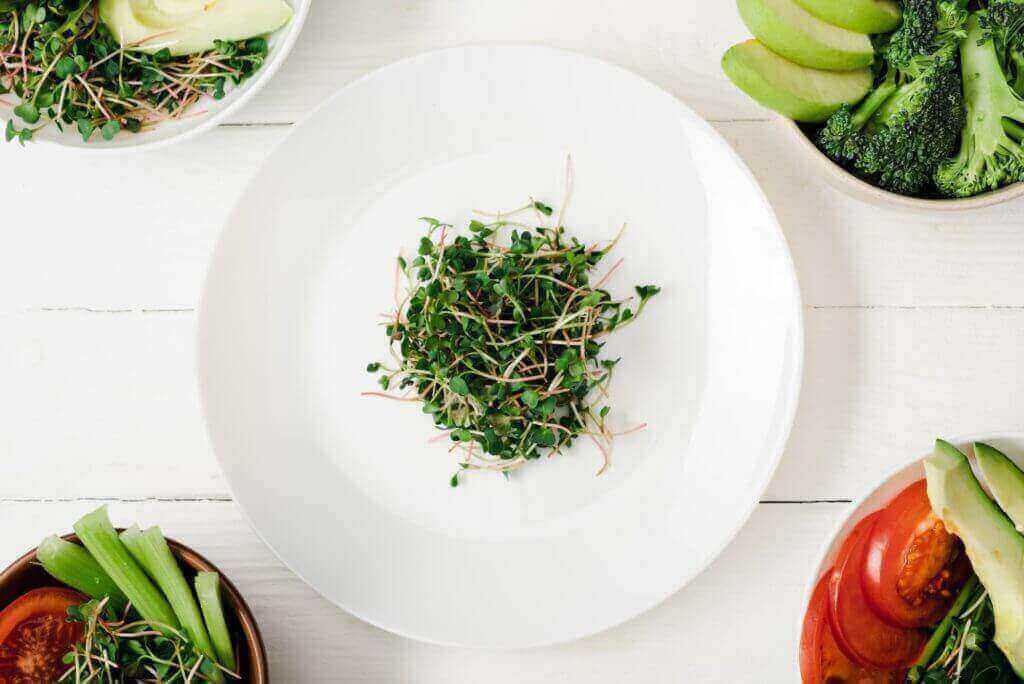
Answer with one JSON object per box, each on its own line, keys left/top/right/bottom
{"left": 0, "top": 0, "right": 267, "bottom": 143}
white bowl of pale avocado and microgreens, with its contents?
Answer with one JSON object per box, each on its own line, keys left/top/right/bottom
{"left": 0, "top": 0, "right": 311, "bottom": 151}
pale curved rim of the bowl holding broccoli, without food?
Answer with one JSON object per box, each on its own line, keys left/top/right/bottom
{"left": 776, "top": 117, "right": 1024, "bottom": 213}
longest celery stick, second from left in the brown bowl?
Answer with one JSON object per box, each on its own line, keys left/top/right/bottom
{"left": 75, "top": 506, "right": 180, "bottom": 633}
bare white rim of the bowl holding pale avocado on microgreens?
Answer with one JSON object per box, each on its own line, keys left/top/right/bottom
{"left": 0, "top": 0, "right": 312, "bottom": 153}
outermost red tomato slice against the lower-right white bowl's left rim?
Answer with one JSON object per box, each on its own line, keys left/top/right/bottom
{"left": 800, "top": 571, "right": 906, "bottom": 684}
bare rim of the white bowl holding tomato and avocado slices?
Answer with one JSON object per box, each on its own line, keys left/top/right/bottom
{"left": 795, "top": 432, "right": 1024, "bottom": 672}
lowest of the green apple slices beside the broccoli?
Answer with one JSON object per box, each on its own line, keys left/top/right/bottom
{"left": 722, "top": 40, "right": 871, "bottom": 123}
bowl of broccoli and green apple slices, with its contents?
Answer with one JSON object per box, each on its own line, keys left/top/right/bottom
{"left": 722, "top": 0, "right": 1024, "bottom": 210}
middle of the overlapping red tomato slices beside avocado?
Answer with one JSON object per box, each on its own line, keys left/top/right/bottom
{"left": 828, "top": 511, "right": 928, "bottom": 670}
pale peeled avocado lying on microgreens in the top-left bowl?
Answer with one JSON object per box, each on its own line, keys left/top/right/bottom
{"left": 99, "top": 0, "right": 293, "bottom": 55}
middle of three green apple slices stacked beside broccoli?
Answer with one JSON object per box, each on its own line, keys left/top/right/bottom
{"left": 736, "top": 0, "right": 874, "bottom": 71}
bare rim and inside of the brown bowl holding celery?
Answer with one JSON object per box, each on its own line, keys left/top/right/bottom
{"left": 0, "top": 530, "right": 270, "bottom": 684}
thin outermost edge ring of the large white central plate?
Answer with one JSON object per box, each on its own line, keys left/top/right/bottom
{"left": 194, "top": 44, "right": 806, "bottom": 651}
